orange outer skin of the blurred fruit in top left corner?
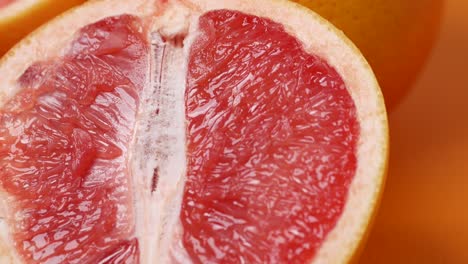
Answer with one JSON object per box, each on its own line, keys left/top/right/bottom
{"left": 0, "top": 0, "right": 85, "bottom": 56}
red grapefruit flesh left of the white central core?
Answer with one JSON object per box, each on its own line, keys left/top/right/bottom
{"left": 0, "top": 16, "right": 148, "bottom": 263}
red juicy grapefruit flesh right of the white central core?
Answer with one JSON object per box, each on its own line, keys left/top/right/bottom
{"left": 181, "top": 11, "right": 359, "bottom": 263}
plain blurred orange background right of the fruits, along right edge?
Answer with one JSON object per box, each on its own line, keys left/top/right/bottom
{"left": 360, "top": 0, "right": 468, "bottom": 264}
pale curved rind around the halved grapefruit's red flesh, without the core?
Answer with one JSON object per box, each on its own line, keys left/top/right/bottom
{"left": 0, "top": 0, "right": 389, "bottom": 263}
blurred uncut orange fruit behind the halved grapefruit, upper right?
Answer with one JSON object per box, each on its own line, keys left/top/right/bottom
{"left": 293, "top": 0, "right": 443, "bottom": 110}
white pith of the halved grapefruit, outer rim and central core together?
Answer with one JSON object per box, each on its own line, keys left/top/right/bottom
{"left": 0, "top": 0, "right": 388, "bottom": 263}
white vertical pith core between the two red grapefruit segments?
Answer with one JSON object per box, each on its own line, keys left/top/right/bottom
{"left": 130, "top": 2, "right": 198, "bottom": 263}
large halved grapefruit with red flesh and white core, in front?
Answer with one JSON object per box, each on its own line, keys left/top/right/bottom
{"left": 0, "top": 0, "right": 388, "bottom": 263}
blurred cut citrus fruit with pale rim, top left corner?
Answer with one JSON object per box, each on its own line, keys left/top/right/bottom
{"left": 0, "top": 0, "right": 85, "bottom": 56}
